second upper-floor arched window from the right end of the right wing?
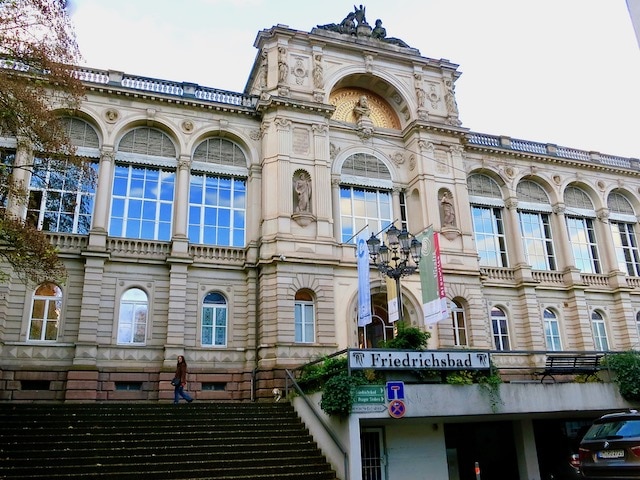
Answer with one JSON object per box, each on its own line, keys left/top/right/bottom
{"left": 564, "top": 187, "right": 601, "bottom": 273}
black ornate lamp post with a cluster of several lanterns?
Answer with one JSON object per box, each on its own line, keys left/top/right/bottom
{"left": 367, "top": 224, "right": 422, "bottom": 321}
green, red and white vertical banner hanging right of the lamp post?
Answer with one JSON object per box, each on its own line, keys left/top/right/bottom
{"left": 418, "top": 227, "right": 449, "bottom": 325}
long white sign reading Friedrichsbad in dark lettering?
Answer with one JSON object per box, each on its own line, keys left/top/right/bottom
{"left": 349, "top": 349, "right": 491, "bottom": 370}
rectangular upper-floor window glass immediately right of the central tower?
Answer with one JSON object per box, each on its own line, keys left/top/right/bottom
{"left": 471, "top": 205, "right": 509, "bottom": 267}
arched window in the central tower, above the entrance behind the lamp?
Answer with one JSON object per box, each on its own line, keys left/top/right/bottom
{"left": 340, "top": 153, "right": 392, "bottom": 242}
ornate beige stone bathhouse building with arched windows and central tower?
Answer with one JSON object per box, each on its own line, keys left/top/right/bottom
{"left": 0, "top": 9, "right": 640, "bottom": 479}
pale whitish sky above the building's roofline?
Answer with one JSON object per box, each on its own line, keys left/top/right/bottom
{"left": 72, "top": 0, "right": 640, "bottom": 158}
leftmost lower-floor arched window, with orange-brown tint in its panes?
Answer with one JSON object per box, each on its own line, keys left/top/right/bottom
{"left": 29, "top": 283, "right": 62, "bottom": 341}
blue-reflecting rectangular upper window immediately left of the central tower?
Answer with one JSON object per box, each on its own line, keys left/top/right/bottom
{"left": 188, "top": 174, "right": 247, "bottom": 247}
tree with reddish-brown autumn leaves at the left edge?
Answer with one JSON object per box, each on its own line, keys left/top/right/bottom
{"left": 0, "top": 0, "right": 90, "bottom": 283}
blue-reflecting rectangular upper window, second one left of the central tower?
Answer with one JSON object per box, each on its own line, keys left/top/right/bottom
{"left": 109, "top": 165, "right": 175, "bottom": 241}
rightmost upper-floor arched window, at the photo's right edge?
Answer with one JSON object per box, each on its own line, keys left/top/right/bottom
{"left": 607, "top": 192, "right": 640, "bottom": 277}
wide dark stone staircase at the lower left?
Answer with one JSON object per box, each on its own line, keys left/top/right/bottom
{"left": 0, "top": 402, "right": 337, "bottom": 480}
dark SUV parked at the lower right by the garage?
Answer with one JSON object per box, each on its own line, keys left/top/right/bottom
{"left": 579, "top": 410, "right": 640, "bottom": 480}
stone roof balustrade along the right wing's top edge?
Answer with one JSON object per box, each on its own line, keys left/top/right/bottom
{"left": 467, "top": 132, "right": 640, "bottom": 170}
